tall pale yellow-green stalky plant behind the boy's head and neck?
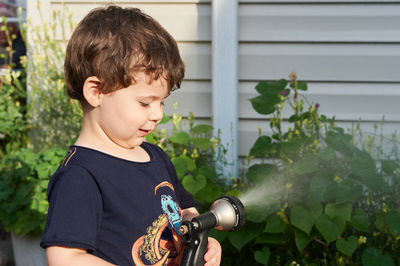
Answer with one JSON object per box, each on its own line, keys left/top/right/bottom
{"left": 28, "top": 1, "right": 82, "bottom": 150}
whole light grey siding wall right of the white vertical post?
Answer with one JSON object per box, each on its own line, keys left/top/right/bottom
{"left": 239, "top": 0, "right": 400, "bottom": 155}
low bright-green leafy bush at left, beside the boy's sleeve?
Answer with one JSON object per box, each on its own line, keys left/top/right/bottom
{"left": 0, "top": 148, "right": 66, "bottom": 235}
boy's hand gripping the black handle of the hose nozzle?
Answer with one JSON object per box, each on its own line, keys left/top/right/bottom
{"left": 182, "top": 207, "right": 222, "bottom": 266}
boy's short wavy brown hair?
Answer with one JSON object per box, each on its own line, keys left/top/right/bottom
{"left": 64, "top": 6, "right": 185, "bottom": 103}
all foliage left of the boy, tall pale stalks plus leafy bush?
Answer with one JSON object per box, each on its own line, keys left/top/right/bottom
{"left": 0, "top": 5, "right": 81, "bottom": 234}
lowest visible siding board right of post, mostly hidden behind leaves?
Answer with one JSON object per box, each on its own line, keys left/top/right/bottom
{"left": 238, "top": 120, "right": 400, "bottom": 156}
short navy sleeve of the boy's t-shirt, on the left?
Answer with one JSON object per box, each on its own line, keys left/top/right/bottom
{"left": 40, "top": 165, "right": 102, "bottom": 251}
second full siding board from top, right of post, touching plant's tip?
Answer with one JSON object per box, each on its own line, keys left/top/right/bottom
{"left": 238, "top": 43, "right": 400, "bottom": 82}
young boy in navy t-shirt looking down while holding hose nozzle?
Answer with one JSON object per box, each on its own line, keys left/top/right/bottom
{"left": 41, "top": 6, "right": 221, "bottom": 266}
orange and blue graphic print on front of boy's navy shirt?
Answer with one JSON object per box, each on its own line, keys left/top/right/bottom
{"left": 132, "top": 181, "right": 182, "bottom": 266}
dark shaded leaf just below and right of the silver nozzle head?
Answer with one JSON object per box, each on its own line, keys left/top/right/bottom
{"left": 228, "top": 223, "right": 263, "bottom": 251}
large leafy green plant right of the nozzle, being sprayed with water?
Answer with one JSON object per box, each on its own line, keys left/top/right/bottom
{"left": 220, "top": 73, "right": 400, "bottom": 265}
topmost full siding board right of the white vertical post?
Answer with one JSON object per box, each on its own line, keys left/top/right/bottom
{"left": 239, "top": 4, "right": 400, "bottom": 42}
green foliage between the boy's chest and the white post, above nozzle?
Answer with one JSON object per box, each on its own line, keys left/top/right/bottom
{"left": 146, "top": 106, "right": 227, "bottom": 211}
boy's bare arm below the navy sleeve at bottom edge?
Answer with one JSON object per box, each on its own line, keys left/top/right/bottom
{"left": 46, "top": 246, "right": 115, "bottom": 266}
